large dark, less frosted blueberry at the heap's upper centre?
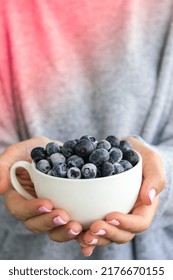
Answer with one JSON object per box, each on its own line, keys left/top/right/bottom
{"left": 74, "top": 139, "right": 94, "bottom": 158}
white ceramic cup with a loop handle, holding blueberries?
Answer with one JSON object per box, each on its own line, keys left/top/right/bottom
{"left": 10, "top": 154, "right": 142, "bottom": 229}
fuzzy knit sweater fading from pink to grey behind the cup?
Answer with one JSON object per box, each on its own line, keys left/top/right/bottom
{"left": 0, "top": 0, "right": 173, "bottom": 259}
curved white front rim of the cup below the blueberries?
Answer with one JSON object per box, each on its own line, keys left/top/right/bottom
{"left": 31, "top": 149, "right": 142, "bottom": 183}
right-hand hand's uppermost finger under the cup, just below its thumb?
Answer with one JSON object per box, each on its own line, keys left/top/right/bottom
{"left": 106, "top": 198, "right": 158, "bottom": 234}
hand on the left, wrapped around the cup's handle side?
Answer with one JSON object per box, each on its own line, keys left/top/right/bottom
{"left": 0, "top": 137, "right": 82, "bottom": 242}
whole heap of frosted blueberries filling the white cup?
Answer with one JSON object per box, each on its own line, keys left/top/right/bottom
{"left": 31, "top": 135, "right": 139, "bottom": 179}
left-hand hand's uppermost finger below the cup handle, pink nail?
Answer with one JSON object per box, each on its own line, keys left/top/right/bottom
{"left": 5, "top": 189, "right": 53, "bottom": 220}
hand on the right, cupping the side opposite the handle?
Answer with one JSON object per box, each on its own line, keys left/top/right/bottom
{"left": 77, "top": 137, "right": 165, "bottom": 256}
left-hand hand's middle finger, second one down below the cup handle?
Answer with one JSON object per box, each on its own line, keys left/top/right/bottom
{"left": 24, "top": 209, "right": 70, "bottom": 233}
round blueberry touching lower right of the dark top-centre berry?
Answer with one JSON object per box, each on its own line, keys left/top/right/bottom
{"left": 89, "top": 148, "right": 109, "bottom": 166}
